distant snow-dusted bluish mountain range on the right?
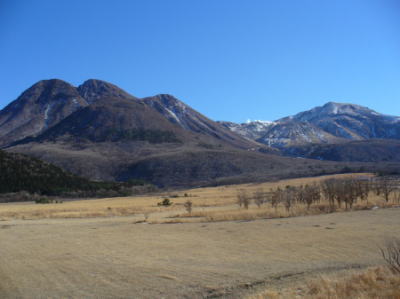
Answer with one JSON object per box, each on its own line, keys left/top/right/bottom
{"left": 222, "top": 102, "right": 400, "bottom": 149}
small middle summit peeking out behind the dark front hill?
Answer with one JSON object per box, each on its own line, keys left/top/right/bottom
{"left": 77, "top": 79, "right": 134, "bottom": 103}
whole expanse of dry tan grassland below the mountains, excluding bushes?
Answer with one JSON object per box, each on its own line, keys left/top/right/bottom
{"left": 0, "top": 174, "right": 400, "bottom": 298}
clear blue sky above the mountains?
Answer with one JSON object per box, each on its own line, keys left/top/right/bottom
{"left": 0, "top": 0, "right": 400, "bottom": 122}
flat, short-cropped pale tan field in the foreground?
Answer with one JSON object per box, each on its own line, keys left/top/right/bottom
{"left": 0, "top": 209, "right": 400, "bottom": 299}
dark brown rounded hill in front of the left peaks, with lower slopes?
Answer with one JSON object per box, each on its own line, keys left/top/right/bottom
{"left": 3, "top": 91, "right": 322, "bottom": 186}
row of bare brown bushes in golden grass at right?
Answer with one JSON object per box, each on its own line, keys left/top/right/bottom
{"left": 174, "top": 176, "right": 400, "bottom": 222}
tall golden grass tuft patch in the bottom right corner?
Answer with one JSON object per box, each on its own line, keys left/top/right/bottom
{"left": 247, "top": 266, "right": 400, "bottom": 299}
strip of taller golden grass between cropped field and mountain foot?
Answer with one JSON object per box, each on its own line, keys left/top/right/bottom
{"left": 0, "top": 173, "right": 398, "bottom": 223}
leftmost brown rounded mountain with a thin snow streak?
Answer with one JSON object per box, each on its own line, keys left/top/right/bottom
{"left": 0, "top": 79, "right": 88, "bottom": 147}
